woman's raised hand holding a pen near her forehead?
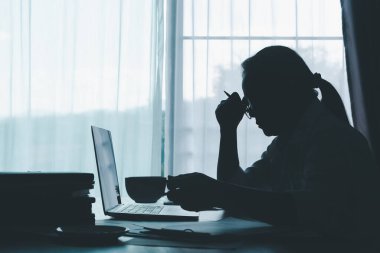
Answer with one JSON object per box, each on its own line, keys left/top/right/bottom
{"left": 215, "top": 92, "right": 245, "bottom": 130}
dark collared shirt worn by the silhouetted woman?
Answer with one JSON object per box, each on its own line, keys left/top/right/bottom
{"left": 240, "top": 100, "right": 380, "bottom": 237}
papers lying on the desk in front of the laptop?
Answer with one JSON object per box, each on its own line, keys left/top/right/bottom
{"left": 98, "top": 217, "right": 277, "bottom": 249}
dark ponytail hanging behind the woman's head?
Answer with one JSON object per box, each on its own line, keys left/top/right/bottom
{"left": 313, "top": 73, "right": 349, "bottom": 123}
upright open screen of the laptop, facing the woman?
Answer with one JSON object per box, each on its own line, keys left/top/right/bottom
{"left": 91, "top": 126, "right": 121, "bottom": 211}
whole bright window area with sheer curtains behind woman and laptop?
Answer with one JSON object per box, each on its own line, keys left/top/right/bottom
{"left": 0, "top": 0, "right": 350, "bottom": 182}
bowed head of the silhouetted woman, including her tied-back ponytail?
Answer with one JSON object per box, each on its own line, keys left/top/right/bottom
{"left": 242, "top": 46, "right": 347, "bottom": 135}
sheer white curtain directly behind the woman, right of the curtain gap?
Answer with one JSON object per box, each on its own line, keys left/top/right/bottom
{"left": 166, "top": 0, "right": 350, "bottom": 177}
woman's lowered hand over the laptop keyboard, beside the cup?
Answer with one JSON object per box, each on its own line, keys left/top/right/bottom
{"left": 167, "top": 173, "right": 222, "bottom": 211}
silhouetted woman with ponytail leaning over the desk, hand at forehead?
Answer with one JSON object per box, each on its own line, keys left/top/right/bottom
{"left": 168, "top": 46, "right": 380, "bottom": 238}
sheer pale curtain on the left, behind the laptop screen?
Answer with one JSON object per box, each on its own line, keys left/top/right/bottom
{"left": 0, "top": 0, "right": 164, "bottom": 191}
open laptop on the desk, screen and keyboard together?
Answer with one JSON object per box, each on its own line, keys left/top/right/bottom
{"left": 91, "top": 126, "right": 199, "bottom": 220}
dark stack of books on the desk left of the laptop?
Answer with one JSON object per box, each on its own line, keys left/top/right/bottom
{"left": 0, "top": 172, "right": 95, "bottom": 228}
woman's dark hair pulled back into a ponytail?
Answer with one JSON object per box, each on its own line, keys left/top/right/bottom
{"left": 242, "top": 46, "right": 349, "bottom": 123}
